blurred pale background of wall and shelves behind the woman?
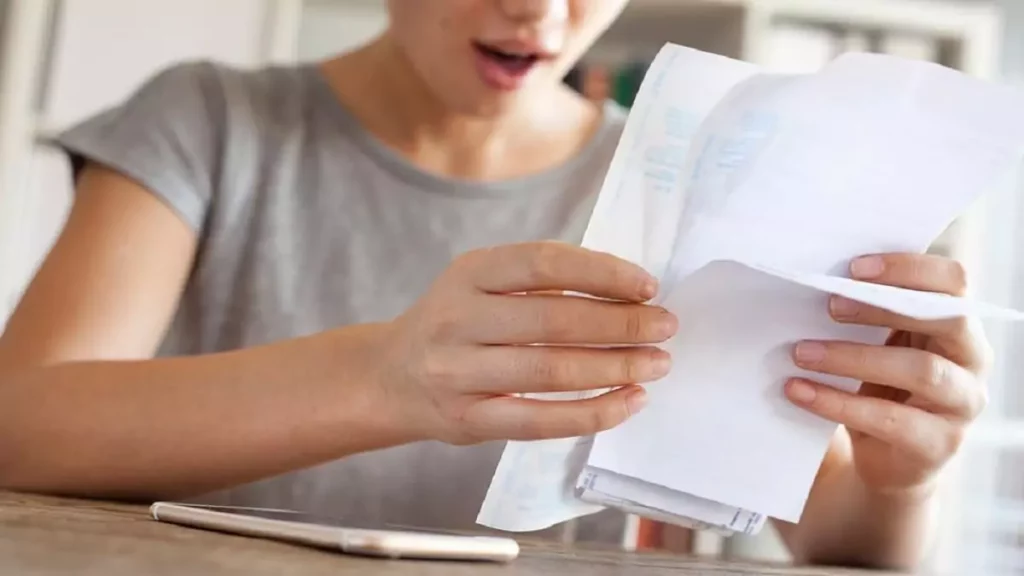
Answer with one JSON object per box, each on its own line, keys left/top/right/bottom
{"left": 0, "top": 0, "right": 1024, "bottom": 574}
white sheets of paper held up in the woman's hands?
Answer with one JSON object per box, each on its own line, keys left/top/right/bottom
{"left": 478, "top": 45, "right": 1024, "bottom": 533}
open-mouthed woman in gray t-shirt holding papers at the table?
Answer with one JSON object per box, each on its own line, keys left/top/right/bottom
{"left": 0, "top": 0, "right": 988, "bottom": 566}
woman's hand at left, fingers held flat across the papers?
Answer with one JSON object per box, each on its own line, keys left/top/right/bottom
{"left": 375, "top": 243, "right": 677, "bottom": 444}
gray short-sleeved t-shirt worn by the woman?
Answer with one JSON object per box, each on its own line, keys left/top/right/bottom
{"left": 57, "top": 63, "right": 626, "bottom": 542}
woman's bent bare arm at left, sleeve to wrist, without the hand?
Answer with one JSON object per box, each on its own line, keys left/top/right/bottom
{"left": 0, "top": 167, "right": 410, "bottom": 498}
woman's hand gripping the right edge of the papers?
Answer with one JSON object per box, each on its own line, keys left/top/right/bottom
{"left": 786, "top": 254, "right": 991, "bottom": 495}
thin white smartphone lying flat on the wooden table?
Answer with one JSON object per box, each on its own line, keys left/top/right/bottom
{"left": 150, "top": 502, "right": 519, "bottom": 563}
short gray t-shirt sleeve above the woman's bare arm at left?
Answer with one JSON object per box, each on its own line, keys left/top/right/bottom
{"left": 51, "top": 61, "right": 225, "bottom": 232}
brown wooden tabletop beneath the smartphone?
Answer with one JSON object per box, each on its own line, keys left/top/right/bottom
{"left": 0, "top": 492, "right": 897, "bottom": 576}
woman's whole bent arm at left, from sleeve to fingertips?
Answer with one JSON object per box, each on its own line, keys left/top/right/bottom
{"left": 0, "top": 163, "right": 677, "bottom": 498}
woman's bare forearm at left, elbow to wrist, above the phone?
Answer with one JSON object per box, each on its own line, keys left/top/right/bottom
{"left": 0, "top": 319, "right": 407, "bottom": 499}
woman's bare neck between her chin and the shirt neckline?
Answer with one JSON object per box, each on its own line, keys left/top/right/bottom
{"left": 323, "top": 36, "right": 601, "bottom": 180}
